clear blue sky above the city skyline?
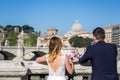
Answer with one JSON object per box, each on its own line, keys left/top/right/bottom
{"left": 0, "top": 0, "right": 120, "bottom": 35}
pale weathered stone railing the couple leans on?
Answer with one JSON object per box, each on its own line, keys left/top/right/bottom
{"left": 0, "top": 61, "right": 120, "bottom": 80}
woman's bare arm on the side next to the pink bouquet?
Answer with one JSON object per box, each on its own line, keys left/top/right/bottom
{"left": 65, "top": 56, "right": 74, "bottom": 74}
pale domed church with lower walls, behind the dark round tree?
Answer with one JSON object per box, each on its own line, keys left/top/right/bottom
{"left": 63, "top": 20, "right": 91, "bottom": 47}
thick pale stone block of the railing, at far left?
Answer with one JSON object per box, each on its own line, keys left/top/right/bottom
{"left": 0, "top": 61, "right": 28, "bottom": 80}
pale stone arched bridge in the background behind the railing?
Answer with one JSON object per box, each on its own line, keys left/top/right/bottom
{"left": 0, "top": 46, "right": 85, "bottom": 60}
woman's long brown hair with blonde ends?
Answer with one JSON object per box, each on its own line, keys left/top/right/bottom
{"left": 48, "top": 37, "right": 62, "bottom": 63}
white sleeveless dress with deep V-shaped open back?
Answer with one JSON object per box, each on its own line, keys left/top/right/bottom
{"left": 46, "top": 55, "right": 66, "bottom": 80}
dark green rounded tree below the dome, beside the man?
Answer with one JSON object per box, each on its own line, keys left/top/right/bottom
{"left": 69, "top": 36, "right": 92, "bottom": 48}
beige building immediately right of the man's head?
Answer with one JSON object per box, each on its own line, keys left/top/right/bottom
{"left": 104, "top": 25, "right": 113, "bottom": 43}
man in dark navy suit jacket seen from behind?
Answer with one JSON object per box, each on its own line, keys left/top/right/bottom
{"left": 79, "top": 27, "right": 119, "bottom": 80}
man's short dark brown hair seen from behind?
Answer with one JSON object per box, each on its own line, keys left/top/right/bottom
{"left": 93, "top": 27, "right": 105, "bottom": 40}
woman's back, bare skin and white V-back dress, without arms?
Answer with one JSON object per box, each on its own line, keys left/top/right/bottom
{"left": 46, "top": 55, "right": 65, "bottom": 80}
